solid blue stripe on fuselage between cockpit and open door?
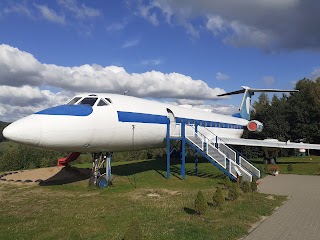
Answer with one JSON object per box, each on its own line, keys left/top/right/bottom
{"left": 118, "top": 111, "right": 169, "bottom": 124}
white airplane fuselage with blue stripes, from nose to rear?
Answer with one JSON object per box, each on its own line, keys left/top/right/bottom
{"left": 3, "top": 94, "right": 248, "bottom": 152}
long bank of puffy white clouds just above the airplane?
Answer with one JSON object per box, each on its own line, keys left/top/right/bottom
{"left": 0, "top": 44, "right": 224, "bottom": 121}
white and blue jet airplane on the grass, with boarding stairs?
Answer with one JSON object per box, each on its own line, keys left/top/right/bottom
{"left": 3, "top": 86, "right": 320, "bottom": 188}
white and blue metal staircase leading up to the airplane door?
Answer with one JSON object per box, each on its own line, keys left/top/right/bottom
{"left": 168, "top": 123, "right": 260, "bottom": 182}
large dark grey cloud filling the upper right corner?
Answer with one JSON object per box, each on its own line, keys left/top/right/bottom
{"left": 138, "top": 0, "right": 320, "bottom": 51}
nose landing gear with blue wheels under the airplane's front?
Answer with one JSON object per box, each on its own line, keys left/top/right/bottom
{"left": 89, "top": 152, "right": 112, "bottom": 188}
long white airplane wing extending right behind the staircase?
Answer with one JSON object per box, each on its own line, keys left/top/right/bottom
{"left": 221, "top": 138, "right": 320, "bottom": 150}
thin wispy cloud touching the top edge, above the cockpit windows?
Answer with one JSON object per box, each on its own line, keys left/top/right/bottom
{"left": 58, "top": 0, "right": 101, "bottom": 19}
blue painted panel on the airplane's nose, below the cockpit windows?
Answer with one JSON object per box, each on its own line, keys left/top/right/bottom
{"left": 35, "top": 105, "right": 93, "bottom": 117}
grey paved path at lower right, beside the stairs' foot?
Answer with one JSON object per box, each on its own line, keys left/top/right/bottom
{"left": 245, "top": 174, "right": 320, "bottom": 240}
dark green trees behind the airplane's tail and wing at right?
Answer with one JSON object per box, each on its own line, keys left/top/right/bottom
{"left": 241, "top": 78, "right": 320, "bottom": 157}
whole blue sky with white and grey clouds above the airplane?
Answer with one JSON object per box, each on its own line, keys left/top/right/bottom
{"left": 0, "top": 0, "right": 320, "bottom": 122}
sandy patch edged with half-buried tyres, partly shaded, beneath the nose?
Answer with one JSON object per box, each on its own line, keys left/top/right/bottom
{"left": 1, "top": 167, "right": 90, "bottom": 186}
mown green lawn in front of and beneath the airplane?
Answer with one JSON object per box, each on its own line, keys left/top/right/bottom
{"left": 0, "top": 160, "right": 285, "bottom": 239}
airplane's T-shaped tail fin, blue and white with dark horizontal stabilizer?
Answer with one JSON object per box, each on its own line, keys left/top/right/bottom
{"left": 218, "top": 86, "right": 299, "bottom": 120}
